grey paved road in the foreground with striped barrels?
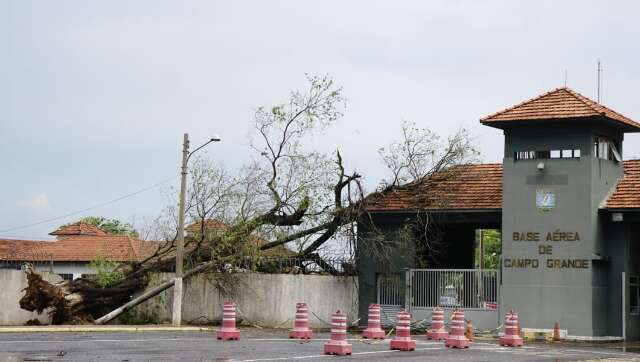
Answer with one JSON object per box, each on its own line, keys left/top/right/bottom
{"left": 0, "top": 329, "right": 640, "bottom": 362}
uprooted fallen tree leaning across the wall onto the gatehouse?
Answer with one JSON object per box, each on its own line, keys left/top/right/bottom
{"left": 20, "top": 77, "right": 476, "bottom": 324}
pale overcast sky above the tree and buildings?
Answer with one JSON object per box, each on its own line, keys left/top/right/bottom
{"left": 0, "top": 0, "right": 640, "bottom": 239}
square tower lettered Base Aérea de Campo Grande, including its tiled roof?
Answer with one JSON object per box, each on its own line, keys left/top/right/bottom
{"left": 480, "top": 88, "right": 640, "bottom": 336}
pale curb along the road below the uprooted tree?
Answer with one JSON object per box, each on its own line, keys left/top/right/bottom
{"left": 0, "top": 325, "right": 215, "bottom": 333}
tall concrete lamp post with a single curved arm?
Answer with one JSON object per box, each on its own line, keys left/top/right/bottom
{"left": 172, "top": 133, "right": 221, "bottom": 327}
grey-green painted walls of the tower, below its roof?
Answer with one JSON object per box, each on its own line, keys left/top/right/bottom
{"left": 500, "top": 123, "right": 622, "bottom": 336}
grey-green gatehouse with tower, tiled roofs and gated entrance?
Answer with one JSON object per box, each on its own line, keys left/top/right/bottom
{"left": 357, "top": 87, "right": 640, "bottom": 340}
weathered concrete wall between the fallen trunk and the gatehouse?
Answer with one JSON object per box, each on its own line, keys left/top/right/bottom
{"left": 135, "top": 273, "right": 358, "bottom": 328}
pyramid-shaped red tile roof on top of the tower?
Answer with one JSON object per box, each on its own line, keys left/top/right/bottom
{"left": 480, "top": 87, "right": 640, "bottom": 132}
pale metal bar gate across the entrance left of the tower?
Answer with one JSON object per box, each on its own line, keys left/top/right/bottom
{"left": 377, "top": 269, "right": 500, "bottom": 330}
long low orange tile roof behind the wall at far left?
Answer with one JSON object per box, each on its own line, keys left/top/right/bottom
{"left": 0, "top": 235, "right": 153, "bottom": 262}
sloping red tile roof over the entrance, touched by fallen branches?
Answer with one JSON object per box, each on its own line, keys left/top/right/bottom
{"left": 367, "top": 163, "right": 502, "bottom": 212}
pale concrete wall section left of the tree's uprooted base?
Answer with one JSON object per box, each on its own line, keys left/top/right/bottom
{"left": 0, "top": 269, "right": 62, "bottom": 326}
